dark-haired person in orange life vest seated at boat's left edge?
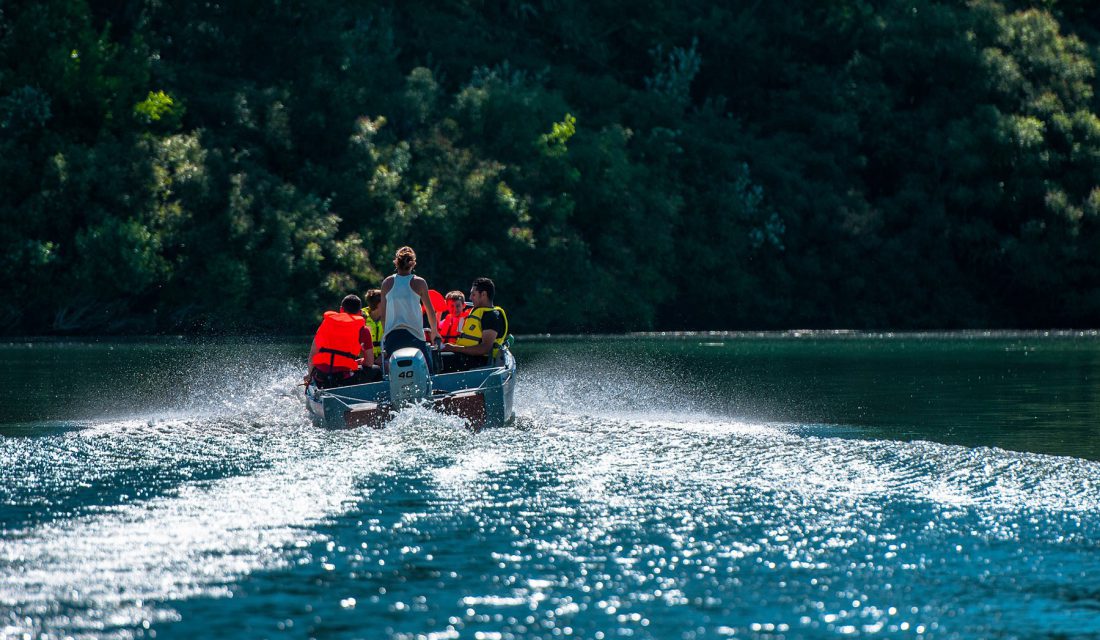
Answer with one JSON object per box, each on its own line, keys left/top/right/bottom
{"left": 306, "top": 295, "right": 382, "bottom": 388}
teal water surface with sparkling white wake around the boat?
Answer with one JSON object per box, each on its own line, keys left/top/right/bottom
{"left": 0, "top": 333, "right": 1100, "bottom": 640}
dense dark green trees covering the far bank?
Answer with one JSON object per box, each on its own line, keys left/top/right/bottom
{"left": 0, "top": 0, "right": 1100, "bottom": 334}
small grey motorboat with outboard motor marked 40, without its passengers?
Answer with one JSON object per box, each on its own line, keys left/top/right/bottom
{"left": 306, "top": 341, "right": 516, "bottom": 430}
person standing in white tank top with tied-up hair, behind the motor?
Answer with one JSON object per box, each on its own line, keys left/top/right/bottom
{"left": 380, "top": 246, "right": 439, "bottom": 368}
